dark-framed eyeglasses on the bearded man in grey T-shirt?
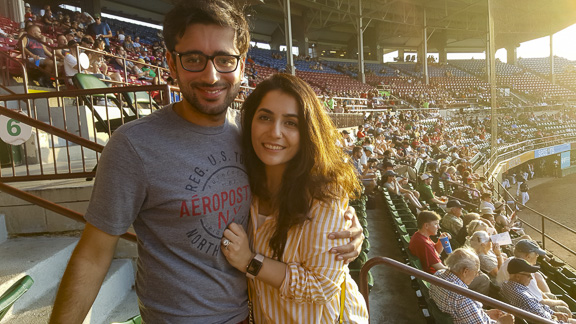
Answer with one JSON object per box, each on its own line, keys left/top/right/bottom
{"left": 173, "top": 52, "right": 242, "bottom": 73}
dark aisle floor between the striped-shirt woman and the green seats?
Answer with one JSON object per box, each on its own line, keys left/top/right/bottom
{"left": 367, "top": 196, "right": 426, "bottom": 324}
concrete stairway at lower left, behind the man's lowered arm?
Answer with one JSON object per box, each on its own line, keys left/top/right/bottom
{"left": 0, "top": 179, "right": 138, "bottom": 324}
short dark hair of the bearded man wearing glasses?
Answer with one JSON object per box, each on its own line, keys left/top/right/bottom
{"left": 163, "top": 0, "right": 250, "bottom": 55}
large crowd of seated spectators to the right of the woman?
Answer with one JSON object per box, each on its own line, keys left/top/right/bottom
{"left": 339, "top": 107, "right": 574, "bottom": 323}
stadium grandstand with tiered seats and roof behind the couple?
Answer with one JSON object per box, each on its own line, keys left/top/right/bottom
{"left": 0, "top": 0, "right": 576, "bottom": 323}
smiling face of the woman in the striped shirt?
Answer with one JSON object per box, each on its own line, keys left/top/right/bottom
{"left": 252, "top": 90, "right": 300, "bottom": 171}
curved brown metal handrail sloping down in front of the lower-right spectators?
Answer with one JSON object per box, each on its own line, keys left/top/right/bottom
{"left": 359, "top": 257, "right": 556, "bottom": 324}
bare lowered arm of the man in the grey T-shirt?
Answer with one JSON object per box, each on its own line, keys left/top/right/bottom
{"left": 50, "top": 223, "right": 119, "bottom": 324}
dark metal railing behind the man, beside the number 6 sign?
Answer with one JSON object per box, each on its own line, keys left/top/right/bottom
{"left": 0, "top": 85, "right": 171, "bottom": 182}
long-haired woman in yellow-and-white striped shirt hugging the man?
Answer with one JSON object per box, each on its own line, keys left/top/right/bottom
{"left": 222, "top": 74, "right": 368, "bottom": 323}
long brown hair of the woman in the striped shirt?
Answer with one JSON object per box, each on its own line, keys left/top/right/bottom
{"left": 242, "top": 74, "right": 360, "bottom": 260}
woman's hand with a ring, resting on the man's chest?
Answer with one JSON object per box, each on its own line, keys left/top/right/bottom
{"left": 220, "top": 223, "right": 254, "bottom": 273}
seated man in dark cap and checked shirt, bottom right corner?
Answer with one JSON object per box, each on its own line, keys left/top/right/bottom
{"left": 502, "top": 258, "right": 576, "bottom": 323}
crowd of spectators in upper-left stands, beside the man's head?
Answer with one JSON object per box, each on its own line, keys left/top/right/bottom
{"left": 0, "top": 3, "right": 168, "bottom": 87}
